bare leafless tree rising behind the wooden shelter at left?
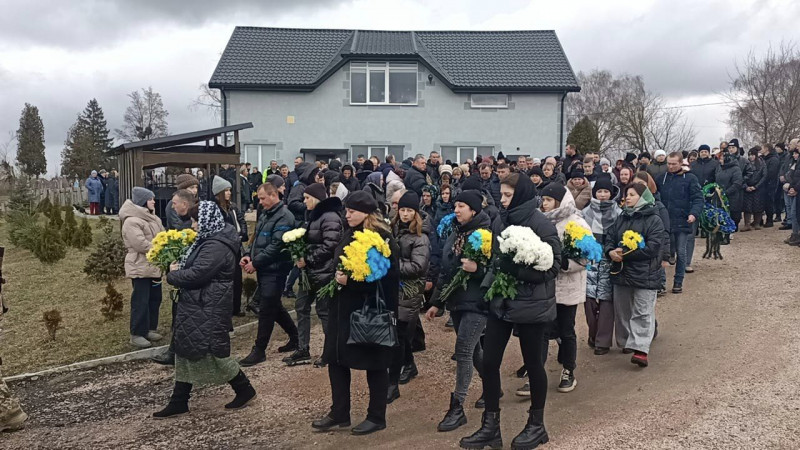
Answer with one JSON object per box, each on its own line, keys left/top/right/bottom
{"left": 114, "top": 87, "right": 169, "bottom": 142}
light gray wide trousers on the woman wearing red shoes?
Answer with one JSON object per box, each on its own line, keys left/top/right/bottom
{"left": 614, "top": 284, "right": 656, "bottom": 353}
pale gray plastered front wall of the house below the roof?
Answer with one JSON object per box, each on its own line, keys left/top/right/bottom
{"left": 227, "top": 65, "right": 561, "bottom": 165}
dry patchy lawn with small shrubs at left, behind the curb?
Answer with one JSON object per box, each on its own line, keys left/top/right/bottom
{"left": 0, "top": 221, "right": 253, "bottom": 376}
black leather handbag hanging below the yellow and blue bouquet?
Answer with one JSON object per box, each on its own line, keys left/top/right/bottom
{"left": 347, "top": 282, "right": 398, "bottom": 347}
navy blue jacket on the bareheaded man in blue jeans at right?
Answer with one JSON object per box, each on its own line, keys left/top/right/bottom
{"left": 656, "top": 172, "right": 703, "bottom": 233}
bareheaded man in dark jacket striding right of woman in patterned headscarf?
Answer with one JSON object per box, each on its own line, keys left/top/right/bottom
{"left": 239, "top": 183, "right": 297, "bottom": 367}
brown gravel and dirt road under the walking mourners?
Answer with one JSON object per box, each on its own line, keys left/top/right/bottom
{"left": 0, "top": 229, "right": 800, "bottom": 449}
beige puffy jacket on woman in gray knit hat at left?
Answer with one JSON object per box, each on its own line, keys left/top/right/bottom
{"left": 119, "top": 200, "right": 164, "bottom": 278}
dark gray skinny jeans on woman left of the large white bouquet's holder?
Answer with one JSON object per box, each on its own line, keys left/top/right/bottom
{"left": 450, "top": 311, "right": 486, "bottom": 403}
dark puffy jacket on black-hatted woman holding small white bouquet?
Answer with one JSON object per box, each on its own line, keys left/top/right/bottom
{"left": 305, "top": 197, "right": 344, "bottom": 291}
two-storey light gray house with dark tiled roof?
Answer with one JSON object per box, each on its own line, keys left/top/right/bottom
{"left": 209, "top": 27, "right": 580, "bottom": 167}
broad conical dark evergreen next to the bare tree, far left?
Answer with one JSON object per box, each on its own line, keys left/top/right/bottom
{"left": 61, "top": 99, "right": 116, "bottom": 178}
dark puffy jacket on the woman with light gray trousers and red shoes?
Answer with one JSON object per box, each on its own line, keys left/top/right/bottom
{"left": 604, "top": 205, "right": 666, "bottom": 290}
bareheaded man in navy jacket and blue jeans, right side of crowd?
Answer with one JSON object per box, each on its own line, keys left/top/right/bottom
{"left": 656, "top": 152, "right": 703, "bottom": 294}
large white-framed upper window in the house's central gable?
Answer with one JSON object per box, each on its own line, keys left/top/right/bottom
{"left": 350, "top": 62, "right": 417, "bottom": 105}
